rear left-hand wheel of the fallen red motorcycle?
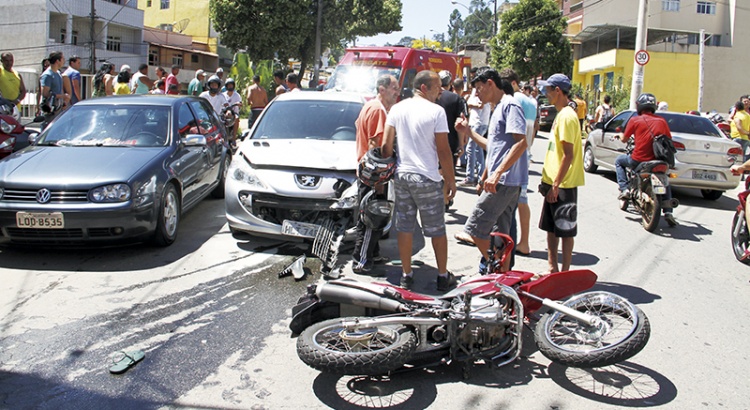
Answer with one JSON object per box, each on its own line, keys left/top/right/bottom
{"left": 297, "top": 318, "right": 417, "bottom": 376}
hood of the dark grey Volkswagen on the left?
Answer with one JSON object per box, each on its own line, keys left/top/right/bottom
{"left": 0, "top": 147, "right": 166, "bottom": 187}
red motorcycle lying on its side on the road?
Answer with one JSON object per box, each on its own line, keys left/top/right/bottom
{"left": 290, "top": 234, "right": 651, "bottom": 377}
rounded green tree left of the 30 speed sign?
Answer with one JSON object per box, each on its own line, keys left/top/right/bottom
{"left": 490, "top": 0, "right": 573, "bottom": 79}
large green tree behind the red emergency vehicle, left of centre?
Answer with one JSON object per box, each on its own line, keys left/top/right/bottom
{"left": 210, "top": 0, "right": 401, "bottom": 85}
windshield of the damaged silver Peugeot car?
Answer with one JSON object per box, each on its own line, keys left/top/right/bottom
{"left": 252, "top": 100, "right": 362, "bottom": 141}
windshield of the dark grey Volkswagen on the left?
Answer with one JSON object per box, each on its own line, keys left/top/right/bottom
{"left": 37, "top": 104, "right": 170, "bottom": 147}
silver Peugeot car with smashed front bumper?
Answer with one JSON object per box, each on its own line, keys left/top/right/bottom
{"left": 225, "top": 92, "right": 390, "bottom": 239}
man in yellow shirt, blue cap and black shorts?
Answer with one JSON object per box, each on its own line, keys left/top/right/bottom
{"left": 539, "top": 74, "right": 584, "bottom": 273}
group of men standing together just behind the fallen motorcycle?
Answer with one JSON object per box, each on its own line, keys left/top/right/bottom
{"left": 352, "top": 67, "right": 584, "bottom": 291}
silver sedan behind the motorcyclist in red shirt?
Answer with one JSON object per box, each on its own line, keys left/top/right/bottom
{"left": 583, "top": 110, "right": 742, "bottom": 200}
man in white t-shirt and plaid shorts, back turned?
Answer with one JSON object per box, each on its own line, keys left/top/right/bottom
{"left": 382, "top": 70, "right": 456, "bottom": 291}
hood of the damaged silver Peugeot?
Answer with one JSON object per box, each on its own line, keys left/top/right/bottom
{"left": 241, "top": 139, "right": 357, "bottom": 171}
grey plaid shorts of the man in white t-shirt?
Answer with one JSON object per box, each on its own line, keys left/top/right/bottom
{"left": 393, "top": 173, "right": 445, "bottom": 238}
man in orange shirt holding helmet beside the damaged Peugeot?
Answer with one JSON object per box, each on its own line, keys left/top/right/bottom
{"left": 352, "top": 75, "right": 399, "bottom": 273}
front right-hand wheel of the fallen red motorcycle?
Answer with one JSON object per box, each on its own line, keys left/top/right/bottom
{"left": 534, "top": 292, "right": 651, "bottom": 368}
